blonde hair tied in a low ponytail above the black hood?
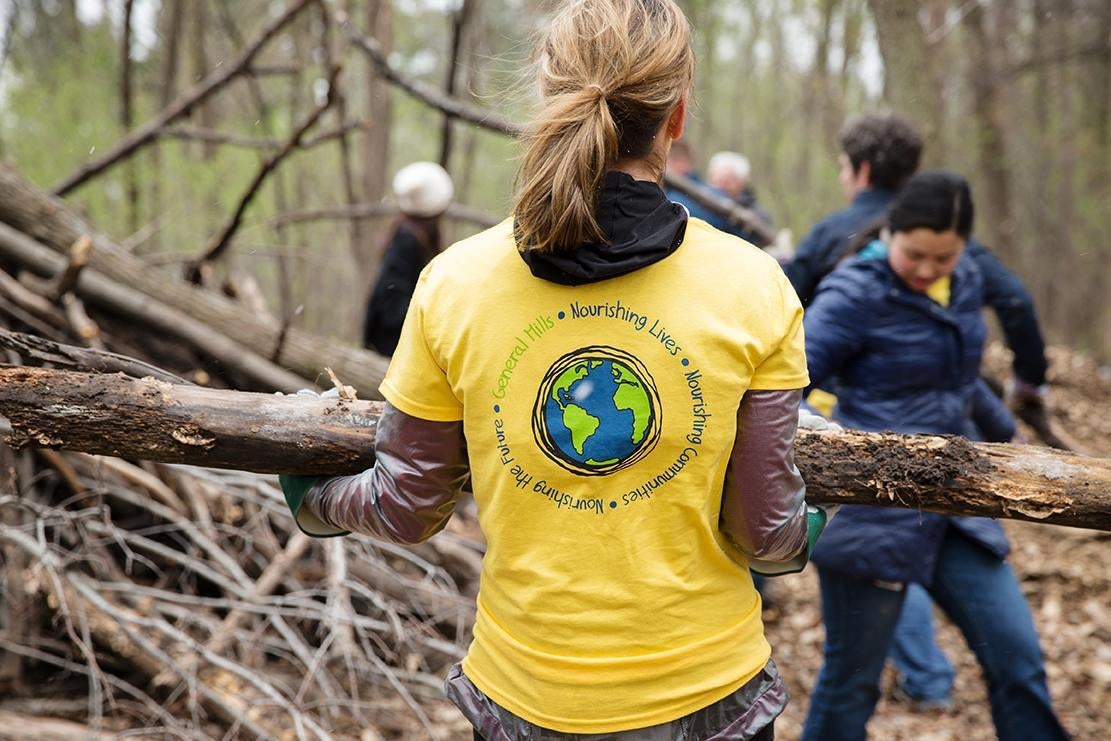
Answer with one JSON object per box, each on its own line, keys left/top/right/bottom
{"left": 513, "top": 0, "right": 694, "bottom": 252}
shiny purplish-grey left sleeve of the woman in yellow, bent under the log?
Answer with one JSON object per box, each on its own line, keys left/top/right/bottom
{"left": 303, "top": 402, "right": 470, "bottom": 543}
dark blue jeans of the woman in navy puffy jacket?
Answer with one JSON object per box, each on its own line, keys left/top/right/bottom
{"left": 802, "top": 528, "right": 1069, "bottom": 741}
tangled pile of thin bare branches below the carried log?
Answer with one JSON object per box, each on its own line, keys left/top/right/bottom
{"left": 0, "top": 448, "right": 481, "bottom": 739}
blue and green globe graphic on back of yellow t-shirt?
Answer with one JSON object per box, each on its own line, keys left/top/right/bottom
{"left": 533, "top": 346, "right": 660, "bottom": 475}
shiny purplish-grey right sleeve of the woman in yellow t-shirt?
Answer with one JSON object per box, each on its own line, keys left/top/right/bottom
{"left": 721, "top": 389, "right": 808, "bottom": 572}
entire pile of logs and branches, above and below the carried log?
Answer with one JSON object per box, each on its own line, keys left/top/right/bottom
{"left": 0, "top": 140, "right": 473, "bottom": 739}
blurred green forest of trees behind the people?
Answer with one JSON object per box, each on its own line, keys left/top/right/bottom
{"left": 0, "top": 0, "right": 1111, "bottom": 363}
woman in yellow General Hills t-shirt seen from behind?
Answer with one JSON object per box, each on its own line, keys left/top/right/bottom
{"left": 282, "top": 0, "right": 827, "bottom": 741}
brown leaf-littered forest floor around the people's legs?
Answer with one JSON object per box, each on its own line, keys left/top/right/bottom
{"left": 422, "top": 344, "right": 1111, "bottom": 741}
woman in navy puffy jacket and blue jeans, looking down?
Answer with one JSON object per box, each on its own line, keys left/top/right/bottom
{"left": 803, "top": 172, "right": 1068, "bottom": 741}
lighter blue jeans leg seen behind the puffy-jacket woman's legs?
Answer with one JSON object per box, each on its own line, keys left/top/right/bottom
{"left": 888, "top": 583, "right": 953, "bottom": 700}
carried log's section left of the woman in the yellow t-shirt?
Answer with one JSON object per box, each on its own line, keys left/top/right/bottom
{"left": 0, "top": 367, "right": 381, "bottom": 473}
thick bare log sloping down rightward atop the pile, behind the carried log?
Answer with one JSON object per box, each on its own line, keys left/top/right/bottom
{"left": 0, "top": 164, "right": 388, "bottom": 397}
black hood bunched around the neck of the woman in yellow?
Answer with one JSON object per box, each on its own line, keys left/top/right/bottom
{"left": 518, "top": 171, "right": 687, "bottom": 286}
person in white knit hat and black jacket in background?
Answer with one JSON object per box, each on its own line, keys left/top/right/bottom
{"left": 362, "top": 162, "right": 456, "bottom": 356}
